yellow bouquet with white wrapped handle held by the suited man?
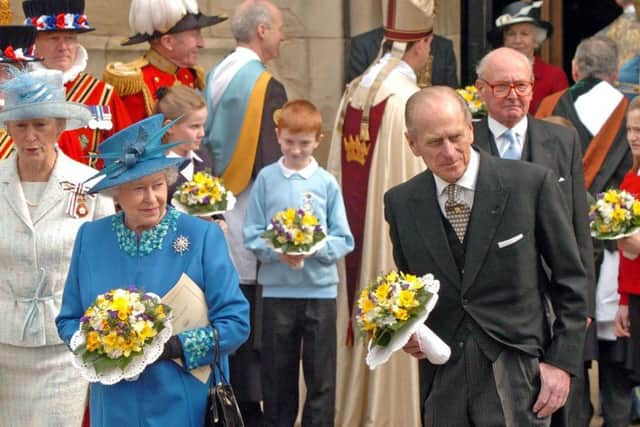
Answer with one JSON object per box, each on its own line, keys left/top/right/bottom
{"left": 355, "top": 271, "right": 451, "bottom": 369}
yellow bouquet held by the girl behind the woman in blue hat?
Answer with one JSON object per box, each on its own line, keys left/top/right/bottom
{"left": 172, "top": 171, "right": 236, "bottom": 216}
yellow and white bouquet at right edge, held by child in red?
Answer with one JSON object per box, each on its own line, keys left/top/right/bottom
{"left": 589, "top": 189, "right": 640, "bottom": 240}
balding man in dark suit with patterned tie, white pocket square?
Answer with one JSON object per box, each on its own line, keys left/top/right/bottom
{"left": 385, "top": 87, "right": 586, "bottom": 426}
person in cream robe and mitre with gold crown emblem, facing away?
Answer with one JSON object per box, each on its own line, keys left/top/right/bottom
{"left": 327, "top": 0, "right": 435, "bottom": 426}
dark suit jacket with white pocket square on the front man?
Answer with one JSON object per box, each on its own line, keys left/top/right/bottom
{"left": 384, "top": 151, "right": 587, "bottom": 388}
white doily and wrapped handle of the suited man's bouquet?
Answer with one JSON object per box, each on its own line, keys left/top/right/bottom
{"left": 366, "top": 280, "right": 451, "bottom": 369}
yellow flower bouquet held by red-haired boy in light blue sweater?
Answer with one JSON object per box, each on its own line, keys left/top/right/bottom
{"left": 262, "top": 208, "right": 326, "bottom": 255}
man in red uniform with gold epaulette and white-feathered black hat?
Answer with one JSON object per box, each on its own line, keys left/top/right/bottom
{"left": 104, "top": 0, "right": 227, "bottom": 121}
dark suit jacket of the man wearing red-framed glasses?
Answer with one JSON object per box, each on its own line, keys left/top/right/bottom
{"left": 474, "top": 116, "right": 595, "bottom": 318}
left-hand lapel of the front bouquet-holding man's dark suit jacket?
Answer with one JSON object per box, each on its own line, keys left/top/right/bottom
{"left": 411, "top": 171, "right": 460, "bottom": 287}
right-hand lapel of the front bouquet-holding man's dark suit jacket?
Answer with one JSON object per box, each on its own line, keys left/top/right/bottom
{"left": 462, "top": 152, "right": 509, "bottom": 292}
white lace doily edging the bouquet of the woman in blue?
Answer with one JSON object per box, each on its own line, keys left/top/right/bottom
{"left": 69, "top": 294, "right": 173, "bottom": 385}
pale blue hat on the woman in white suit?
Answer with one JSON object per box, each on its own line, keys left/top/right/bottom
{"left": 0, "top": 68, "right": 91, "bottom": 130}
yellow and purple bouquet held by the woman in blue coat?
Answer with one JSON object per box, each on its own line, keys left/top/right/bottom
{"left": 71, "top": 286, "right": 172, "bottom": 384}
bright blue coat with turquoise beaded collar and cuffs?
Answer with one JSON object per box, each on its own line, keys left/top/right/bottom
{"left": 56, "top": 208, "right": 249, "bottom": 427}
